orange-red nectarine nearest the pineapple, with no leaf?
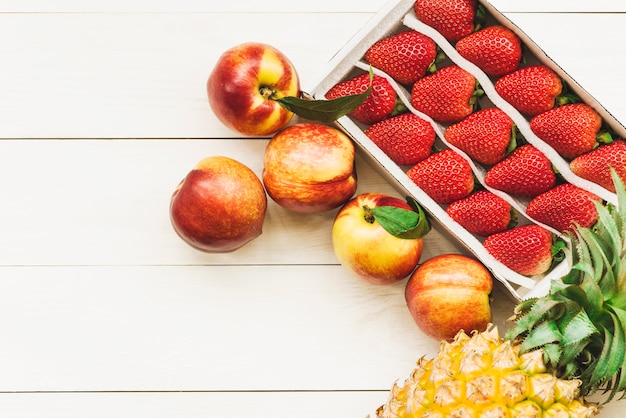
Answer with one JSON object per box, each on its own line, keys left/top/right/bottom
{"left": 404, "top": 254, "right": 493, "bottom": 341}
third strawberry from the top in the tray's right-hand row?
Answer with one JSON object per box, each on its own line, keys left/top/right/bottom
{"left": 495, "top": 65, "right": 563, "bottom": 116}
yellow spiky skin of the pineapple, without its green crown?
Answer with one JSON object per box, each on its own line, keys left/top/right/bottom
{"left": 376, "top": 326, "right": 600, "bottom": 418}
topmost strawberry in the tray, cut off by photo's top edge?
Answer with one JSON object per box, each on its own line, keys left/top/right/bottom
{"left": 414, "top": 0, "right": 476, "bottom": 43}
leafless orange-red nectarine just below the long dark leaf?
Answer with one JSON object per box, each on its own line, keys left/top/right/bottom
{"left": 262, "top": 123, "right": 357, "bottom": 213}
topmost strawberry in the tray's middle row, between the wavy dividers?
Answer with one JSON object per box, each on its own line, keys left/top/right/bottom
{"left": 365, "top": 30, "right": 437, "bottom": 84}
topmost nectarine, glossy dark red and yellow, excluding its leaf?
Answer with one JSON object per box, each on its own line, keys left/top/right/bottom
{"left": 207, "top": 42, "right": 300, "bottom": 136}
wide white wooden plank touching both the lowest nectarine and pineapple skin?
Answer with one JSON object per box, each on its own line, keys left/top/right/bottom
{"left": 0, "top": 265, "right": 513, "bottom": 392}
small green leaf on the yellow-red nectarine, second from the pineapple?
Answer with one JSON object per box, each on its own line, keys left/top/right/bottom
{"left": 363, "top": 197, "right": 430, "bottom": 239}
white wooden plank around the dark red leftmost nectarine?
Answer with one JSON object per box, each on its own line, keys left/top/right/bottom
{"left": 0, "top": 139, "right": 454, "bottom": 265}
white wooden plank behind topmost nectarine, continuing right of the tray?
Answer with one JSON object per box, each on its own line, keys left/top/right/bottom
{"left": 0, "top": 13, "right": 626, "bottom": 138}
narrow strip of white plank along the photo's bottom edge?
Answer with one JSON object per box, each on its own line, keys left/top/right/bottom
{"left": 0, "top": 391, "right": 387, "bottom": 418}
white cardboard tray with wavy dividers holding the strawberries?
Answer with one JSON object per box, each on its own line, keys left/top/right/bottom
{"left": 310, "top": 0, "right": 626, "bottom": 300}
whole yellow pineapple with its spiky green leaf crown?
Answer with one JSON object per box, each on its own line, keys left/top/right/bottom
{"left": 376, "top": 170, "right": 626, "bottom": 418}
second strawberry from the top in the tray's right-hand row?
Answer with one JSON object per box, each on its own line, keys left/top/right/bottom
{"left": 456, "top": 25, "right": 522, "bottom": 77}
